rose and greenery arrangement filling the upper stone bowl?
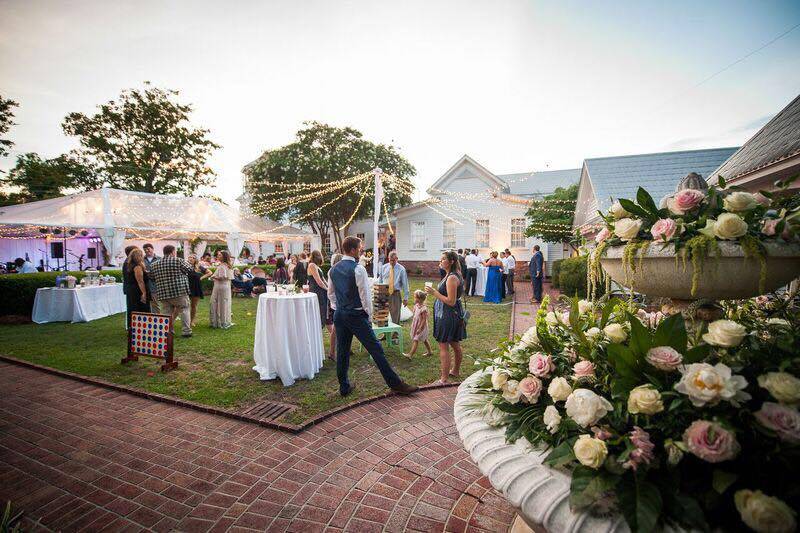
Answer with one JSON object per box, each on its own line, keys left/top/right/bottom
{"left": 589, "top": 178, "right": 800, "bottom": 294}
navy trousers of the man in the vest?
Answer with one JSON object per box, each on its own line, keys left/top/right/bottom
{"left": 333, "top": 310, "right": 401, "bottom": 393}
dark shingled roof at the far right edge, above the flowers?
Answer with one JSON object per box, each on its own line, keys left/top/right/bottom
{"left": 709, "top": 95, "right": 800, "bottom": 181}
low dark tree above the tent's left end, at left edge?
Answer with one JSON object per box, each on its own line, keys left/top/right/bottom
{"left": 0, "top": 153, "right": 91, "bottom": 203}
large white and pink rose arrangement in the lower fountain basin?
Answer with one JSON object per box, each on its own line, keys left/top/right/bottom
{"left": 476, "top": 298, "right": 800, "bottom": 532}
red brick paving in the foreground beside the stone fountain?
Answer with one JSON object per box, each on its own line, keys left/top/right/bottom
{"left": 0, "top": 363, "right": 513, "bottom": 532}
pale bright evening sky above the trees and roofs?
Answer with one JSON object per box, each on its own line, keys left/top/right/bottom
{"left": 0, "top": 0, "right": 800, "bottom": 205}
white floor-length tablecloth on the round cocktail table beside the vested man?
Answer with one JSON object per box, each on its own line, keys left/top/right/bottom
{"left": 253, "top": 292, "right": 325, "bottom": 387}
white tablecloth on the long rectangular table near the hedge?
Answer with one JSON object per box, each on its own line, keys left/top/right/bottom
{"left": 32, "top": 283, "right": 126, "bottom": 324}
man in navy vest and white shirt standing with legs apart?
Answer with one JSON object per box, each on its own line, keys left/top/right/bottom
{"left": 328, "top": 236, "right": 419, "bottom": 396}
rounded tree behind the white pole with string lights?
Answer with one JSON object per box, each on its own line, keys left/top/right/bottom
{"left": 244, "top": 122, "right": 416, "bottom": 247}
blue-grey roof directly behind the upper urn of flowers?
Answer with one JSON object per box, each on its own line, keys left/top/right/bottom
{"left": 583, "top": 147, "right": 737, "bottom": 211}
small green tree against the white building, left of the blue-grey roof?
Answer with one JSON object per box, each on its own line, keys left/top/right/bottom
{"left": 525, "top": 183, "right": 578, "bottom": 246}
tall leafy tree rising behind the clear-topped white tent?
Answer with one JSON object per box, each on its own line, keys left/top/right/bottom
{"left": 61, "top": 83, "right": 219, "bottom": 195}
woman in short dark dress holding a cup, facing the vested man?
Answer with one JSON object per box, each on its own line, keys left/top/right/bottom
{"left": 425, "top": 251, "right": 467, "bottom": 385}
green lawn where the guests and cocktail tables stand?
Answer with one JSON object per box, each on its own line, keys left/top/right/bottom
{"left": 0, "top": 280, "right": 511, "bottom": 424}
